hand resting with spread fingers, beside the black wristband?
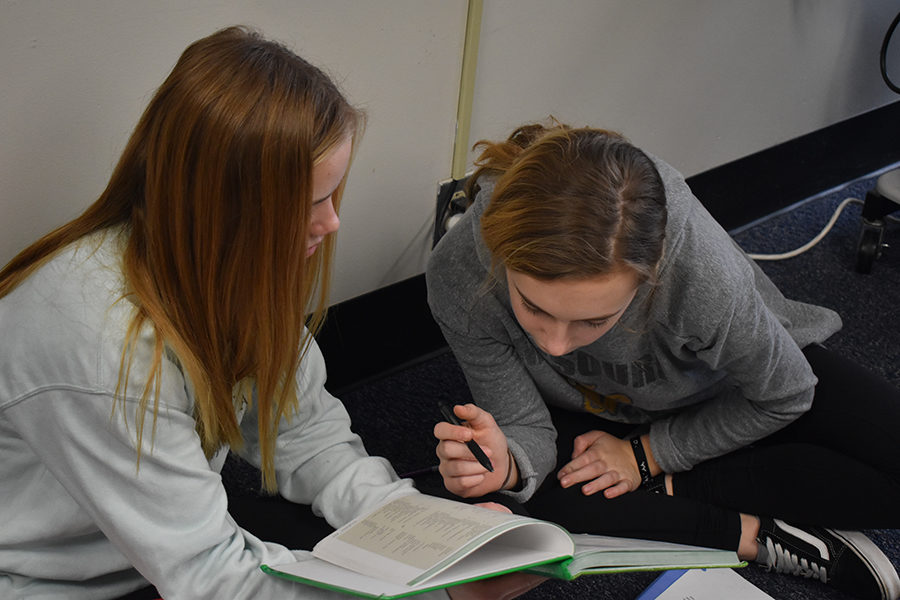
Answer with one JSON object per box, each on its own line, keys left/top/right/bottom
{"left": 557, "top": 431, "right": 655, "bottom": 498}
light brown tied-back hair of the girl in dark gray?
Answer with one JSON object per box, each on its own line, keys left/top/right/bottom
{"left": 470, "top": 123, "right": 667, "bottom": 281}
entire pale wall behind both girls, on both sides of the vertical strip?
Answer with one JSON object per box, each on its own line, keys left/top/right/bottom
{"left": 0, "top": 0, "right": 897, "bottom": 302}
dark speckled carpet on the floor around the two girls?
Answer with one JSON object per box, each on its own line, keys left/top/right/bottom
{"left": 225, "top": 171, "right": 900, "bottom": 600}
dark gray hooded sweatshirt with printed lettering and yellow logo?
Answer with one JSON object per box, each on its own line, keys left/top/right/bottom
{"left": 426, "top": 159, "right": 841, "bottom": 500}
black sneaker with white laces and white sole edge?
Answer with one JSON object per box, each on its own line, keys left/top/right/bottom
{"left": 756, "top": 517, "right": 900, "bottom": 600}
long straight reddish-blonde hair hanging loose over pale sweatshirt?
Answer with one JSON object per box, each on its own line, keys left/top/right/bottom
{"left": 0, "top": 27, "right": 363, "bottom": 490}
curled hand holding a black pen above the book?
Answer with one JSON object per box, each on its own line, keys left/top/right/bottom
{"left": 434, "top": 404, "right": 515, "bottom": 498}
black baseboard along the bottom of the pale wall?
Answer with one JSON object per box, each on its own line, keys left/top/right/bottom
{"left": 317, "top": 102, "right": 900, "bottom": 395}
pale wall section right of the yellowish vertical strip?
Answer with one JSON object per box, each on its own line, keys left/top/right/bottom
{"left": 470, "top": 0, "right": 900, "bottom": 176}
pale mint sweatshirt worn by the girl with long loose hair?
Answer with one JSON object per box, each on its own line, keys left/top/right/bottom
{"left": 0, "top": 230, "right": 447, "bottom": 600}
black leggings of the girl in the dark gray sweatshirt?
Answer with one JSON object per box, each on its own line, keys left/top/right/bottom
{"left": 526, "top": 345, "right": 900, "bottom": 550}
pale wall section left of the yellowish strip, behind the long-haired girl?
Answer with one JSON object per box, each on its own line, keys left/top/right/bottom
{"left": 0, "top": 0, "right": 466, "bottom": 302}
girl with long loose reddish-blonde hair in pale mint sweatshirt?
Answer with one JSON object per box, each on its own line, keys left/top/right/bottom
{"left": 0, "top": 27, "right": 520, "bottom": 600}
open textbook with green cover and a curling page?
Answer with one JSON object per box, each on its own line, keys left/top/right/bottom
{"left": 262, "top": 494, "right": 744, "bottom": 598}
